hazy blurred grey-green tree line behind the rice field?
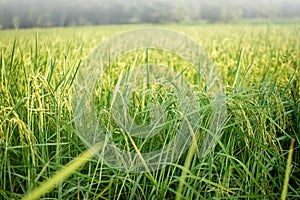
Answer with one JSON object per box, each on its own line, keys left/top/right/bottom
{"left": 0, "top": 0, "right": 300, "bottom": 29}
